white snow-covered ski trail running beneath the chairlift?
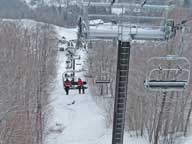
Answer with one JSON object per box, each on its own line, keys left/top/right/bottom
{"left": 45, "top": 50, "right": 105, "bottom": 144}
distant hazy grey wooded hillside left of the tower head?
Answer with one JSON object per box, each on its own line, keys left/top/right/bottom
{"left": 0, "top": 0, "right": 81, "bottom": 27}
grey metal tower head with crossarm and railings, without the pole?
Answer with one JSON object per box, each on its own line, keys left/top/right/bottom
{"left": 78, "top": 2, "right": 173, "bottom": 40}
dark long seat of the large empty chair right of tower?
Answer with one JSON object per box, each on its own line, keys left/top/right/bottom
{"left": 144, "top": 80, "right": 188, "bottom": 89}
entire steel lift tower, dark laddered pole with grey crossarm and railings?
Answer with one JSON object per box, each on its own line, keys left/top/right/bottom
{"left": 78, "top": 1, "right": 174, "bottom": 144}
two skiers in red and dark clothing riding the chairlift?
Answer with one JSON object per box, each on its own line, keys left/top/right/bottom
{"left": 64, "top": 78, "right": 85, "bottom": 95}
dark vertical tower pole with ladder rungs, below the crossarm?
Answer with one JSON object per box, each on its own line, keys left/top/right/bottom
{"left": 112, "top": 37, "right": 131, "bottom": 144}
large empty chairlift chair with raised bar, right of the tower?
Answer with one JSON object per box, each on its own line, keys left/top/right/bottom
{"left": 144, "top": 55, "right": 190, "bottom": 91}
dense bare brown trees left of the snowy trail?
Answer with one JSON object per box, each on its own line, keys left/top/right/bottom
{"left": 0, "top": 21, "right": 57, "bottom": 144}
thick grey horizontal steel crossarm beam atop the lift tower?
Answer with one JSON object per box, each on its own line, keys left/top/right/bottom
{"left": 84, "top": 24, "right": 171, "bottom": 40}
